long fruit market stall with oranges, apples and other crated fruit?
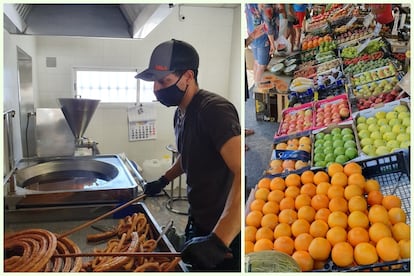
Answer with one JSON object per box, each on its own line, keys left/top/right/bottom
{"left": 244, "top": 4, "right": 411, "bottom": 272}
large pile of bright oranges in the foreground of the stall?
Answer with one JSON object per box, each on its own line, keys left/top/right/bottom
{"left": 245, "top": 162, "right": 410, "bottom": 271}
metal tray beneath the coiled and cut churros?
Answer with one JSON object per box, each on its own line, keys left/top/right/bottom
{"left": 4, "top": 203, "right": 188, "bottom": 272}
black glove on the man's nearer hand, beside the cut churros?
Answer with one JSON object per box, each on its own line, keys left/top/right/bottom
{"left": 181, "top": 233, "right": 232, "bottom": 270}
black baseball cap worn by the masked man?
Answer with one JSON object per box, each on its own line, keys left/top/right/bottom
{"left": 135, "top": 39, "right": 199, "bottom": 81}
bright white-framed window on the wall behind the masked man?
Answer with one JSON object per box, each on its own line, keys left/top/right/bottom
{"left": 74, "top": 68, "right": 156, "bottom": 103}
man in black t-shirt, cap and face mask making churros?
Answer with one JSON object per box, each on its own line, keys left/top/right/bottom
{"left": 136, "top": 39, "right": 241, "bottom": 272}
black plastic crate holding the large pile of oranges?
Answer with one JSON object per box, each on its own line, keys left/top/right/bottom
{"left": 314, "top": 151, "right": 411, "bottom": 272}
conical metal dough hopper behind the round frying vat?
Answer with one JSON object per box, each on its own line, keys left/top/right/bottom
{"left": 58, "top": 98, "right": 100, "bottom": 155}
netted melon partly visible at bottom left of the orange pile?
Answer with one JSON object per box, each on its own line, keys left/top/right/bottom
{"left": 245, "top": 250, "right": 301, "bottom": 272}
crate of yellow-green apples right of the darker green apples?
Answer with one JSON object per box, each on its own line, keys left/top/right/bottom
{"left": 354, "top": 100, "right": 411, "bottom": 156}
